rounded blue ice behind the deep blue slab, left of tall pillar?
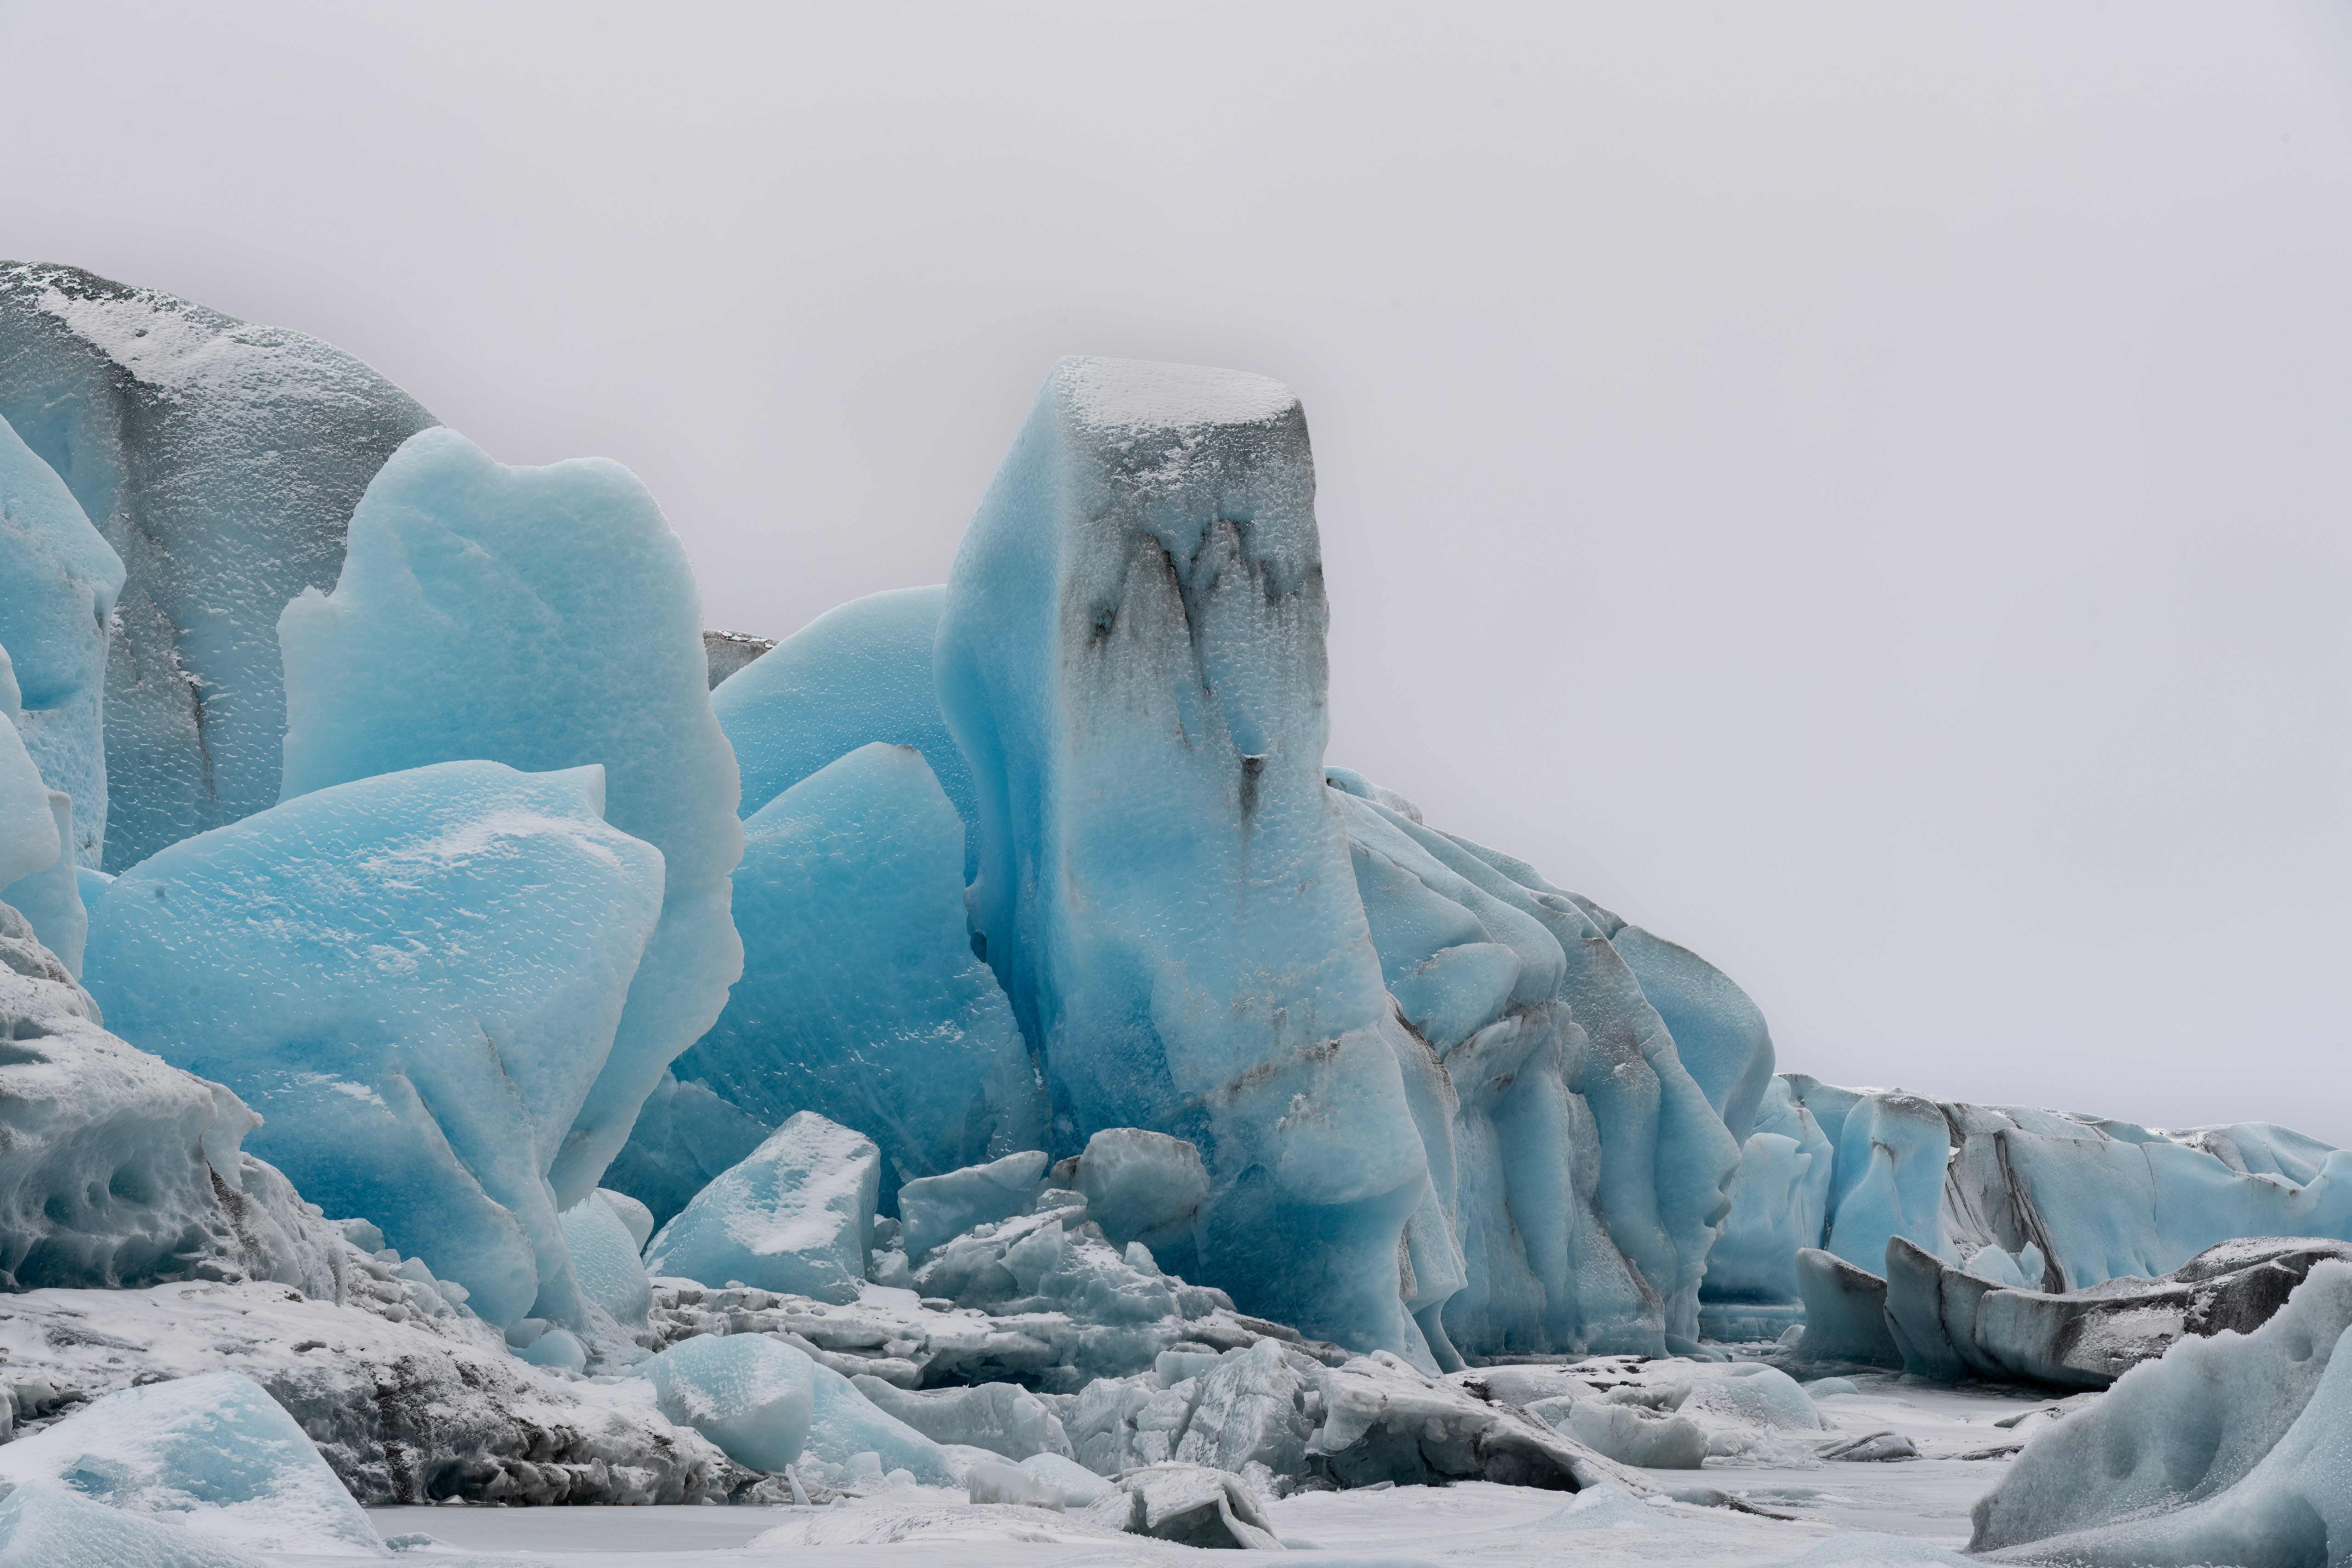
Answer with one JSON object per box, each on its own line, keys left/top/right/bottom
{"left": 710, "top": 588, "right": 981, "bottom": 884}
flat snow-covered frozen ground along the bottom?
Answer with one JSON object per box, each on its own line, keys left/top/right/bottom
{"left": 308, "top": 1375, "right": 2049, "bottom": 1568}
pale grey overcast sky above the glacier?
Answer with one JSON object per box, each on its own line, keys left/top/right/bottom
{"left": 14, "top": 0, "right": 2352, "bottom": 1143}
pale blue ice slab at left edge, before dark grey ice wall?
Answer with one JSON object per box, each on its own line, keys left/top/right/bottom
{"left": 0, "top": 419, "right": 122, "bottom": 865}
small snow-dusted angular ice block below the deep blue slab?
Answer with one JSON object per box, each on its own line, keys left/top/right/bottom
{"left": 645, "top": 1109, "right": 882, "bottom": 1302}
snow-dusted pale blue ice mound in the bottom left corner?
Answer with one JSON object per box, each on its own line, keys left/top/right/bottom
{"left": 0, "top": 1373, "right": 381, "bottom": 1561}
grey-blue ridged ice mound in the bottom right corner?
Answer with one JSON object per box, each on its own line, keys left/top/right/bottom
{"left": 1968, "top": 1262, "right": 2352, "bottom": 1568}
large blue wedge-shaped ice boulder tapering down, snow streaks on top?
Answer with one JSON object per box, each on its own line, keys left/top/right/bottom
{"left": 87, "top": 762, "right": 661, "bottom": 1324}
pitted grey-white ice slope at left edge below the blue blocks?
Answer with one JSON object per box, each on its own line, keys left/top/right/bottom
{"left": 0, "top": 905, "right": 355, "bottom": 1298}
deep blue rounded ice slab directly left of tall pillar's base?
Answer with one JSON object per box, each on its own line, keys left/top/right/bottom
{"left": 678, "top": 742, "right": 1044, "bottom": 1206}
